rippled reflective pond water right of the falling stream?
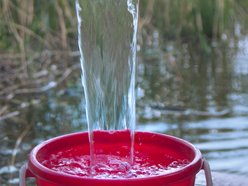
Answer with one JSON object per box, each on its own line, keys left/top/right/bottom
{"left": 137, "top": 34, "right": 248, "bottom": 176}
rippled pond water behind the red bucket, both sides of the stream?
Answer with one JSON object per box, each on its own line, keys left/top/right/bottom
{"left": 0, "top": 37, "right": 248, "bottom": 185}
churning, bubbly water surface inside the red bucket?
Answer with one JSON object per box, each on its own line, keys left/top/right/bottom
{"left": 42, "top": 146, "right": 189, "bottom": 179}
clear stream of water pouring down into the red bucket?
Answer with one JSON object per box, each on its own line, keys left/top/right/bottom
{"left": 76, "top": 0, "right": 139, "bottom": 165}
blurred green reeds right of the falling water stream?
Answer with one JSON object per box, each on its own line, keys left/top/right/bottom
{"left": 140, "top": 0, "right": 248, "bottom": 51}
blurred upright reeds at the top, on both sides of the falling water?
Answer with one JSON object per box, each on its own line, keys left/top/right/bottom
{"left": 0, "top": 0, "right": 248, "bottom": 54}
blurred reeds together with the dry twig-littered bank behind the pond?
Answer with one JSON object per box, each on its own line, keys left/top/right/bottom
{"left": 0, "top": 0, "right": 248, "bottom": 117}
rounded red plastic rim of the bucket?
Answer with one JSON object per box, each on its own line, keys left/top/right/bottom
{"left": 28, "top": 131, "right": 203, "bottom": 184}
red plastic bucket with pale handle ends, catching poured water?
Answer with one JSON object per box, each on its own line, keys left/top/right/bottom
{"left": 20, "top": 131, "right": 212, "bottom": 186}
